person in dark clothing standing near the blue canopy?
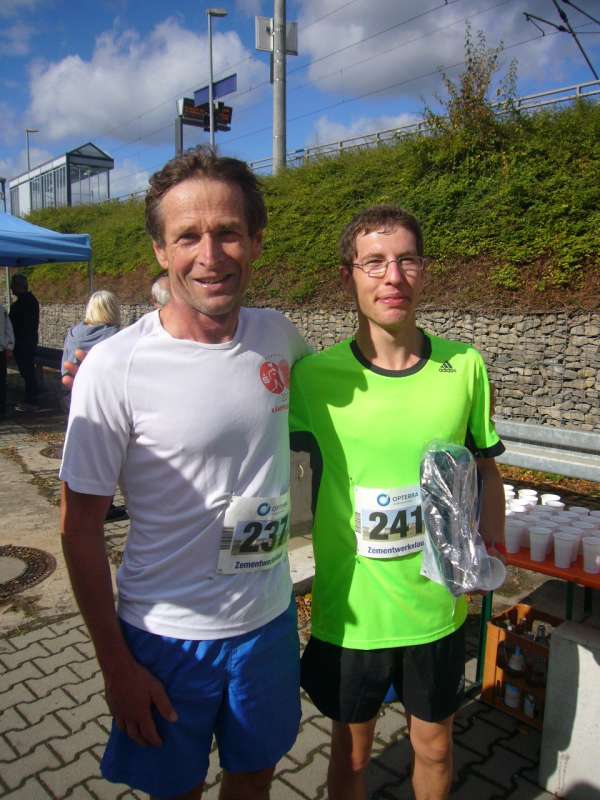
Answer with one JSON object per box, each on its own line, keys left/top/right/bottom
{"left": 10, "top": 275, "right": 40, "bottom": 405}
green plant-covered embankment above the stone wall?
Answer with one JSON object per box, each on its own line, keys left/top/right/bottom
{"left": 24, "top": 103, "right": 600, "bottom": 310}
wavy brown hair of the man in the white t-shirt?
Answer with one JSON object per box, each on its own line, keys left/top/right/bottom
{"left": 145, "top": 146, "right": 267, "bottom": 245}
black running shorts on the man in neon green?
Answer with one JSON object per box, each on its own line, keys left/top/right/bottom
{"left": 300, "top": 625, "right": 465, "bottom": 723}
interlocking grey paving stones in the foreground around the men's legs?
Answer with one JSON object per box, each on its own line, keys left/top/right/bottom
{"left": 0, "top": 613, "right": 553, "bottom": 800}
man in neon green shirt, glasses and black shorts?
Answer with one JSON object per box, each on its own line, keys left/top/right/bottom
{"left": 290, "top": 206, "right": 504, "bottom": 800}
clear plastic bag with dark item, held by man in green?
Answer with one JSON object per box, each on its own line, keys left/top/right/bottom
{"left": 421, "top": 442, "right": 506, "bottom": 597}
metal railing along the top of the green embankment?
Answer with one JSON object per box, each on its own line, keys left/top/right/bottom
{"left": 249, "top": 81, "right": 600, "bottom": 172}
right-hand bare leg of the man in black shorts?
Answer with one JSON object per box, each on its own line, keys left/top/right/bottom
{"left": 407, "top": 714, "right": 454, "bottom": 800}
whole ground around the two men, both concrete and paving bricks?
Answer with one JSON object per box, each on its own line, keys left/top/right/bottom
{"left": 0, "top": 396, "right": 553, "bottom": 800}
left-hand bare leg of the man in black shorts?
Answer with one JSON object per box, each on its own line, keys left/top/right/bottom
{"left": 327, "top": 718, "right": 376, "bottom": 800}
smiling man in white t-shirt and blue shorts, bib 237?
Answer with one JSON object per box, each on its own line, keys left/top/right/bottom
{"left": 60, "top": 148, "right": 308, "bottom": 800}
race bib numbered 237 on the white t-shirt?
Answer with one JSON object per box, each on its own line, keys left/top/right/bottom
{"left": 217, "top": 492, "right": 290, "bottom": 575}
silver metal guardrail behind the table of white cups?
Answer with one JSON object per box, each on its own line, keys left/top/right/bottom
{"left": 496, "top": 419, "right": 600, "bottom": 481}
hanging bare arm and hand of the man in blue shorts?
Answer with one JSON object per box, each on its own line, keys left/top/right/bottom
{"left": 61, "top": 483, "right": 177, "bottom": 746}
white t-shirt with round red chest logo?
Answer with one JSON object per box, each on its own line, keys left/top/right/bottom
{"left": 60, "top": 308, "right": 309, "bottom": 639}
